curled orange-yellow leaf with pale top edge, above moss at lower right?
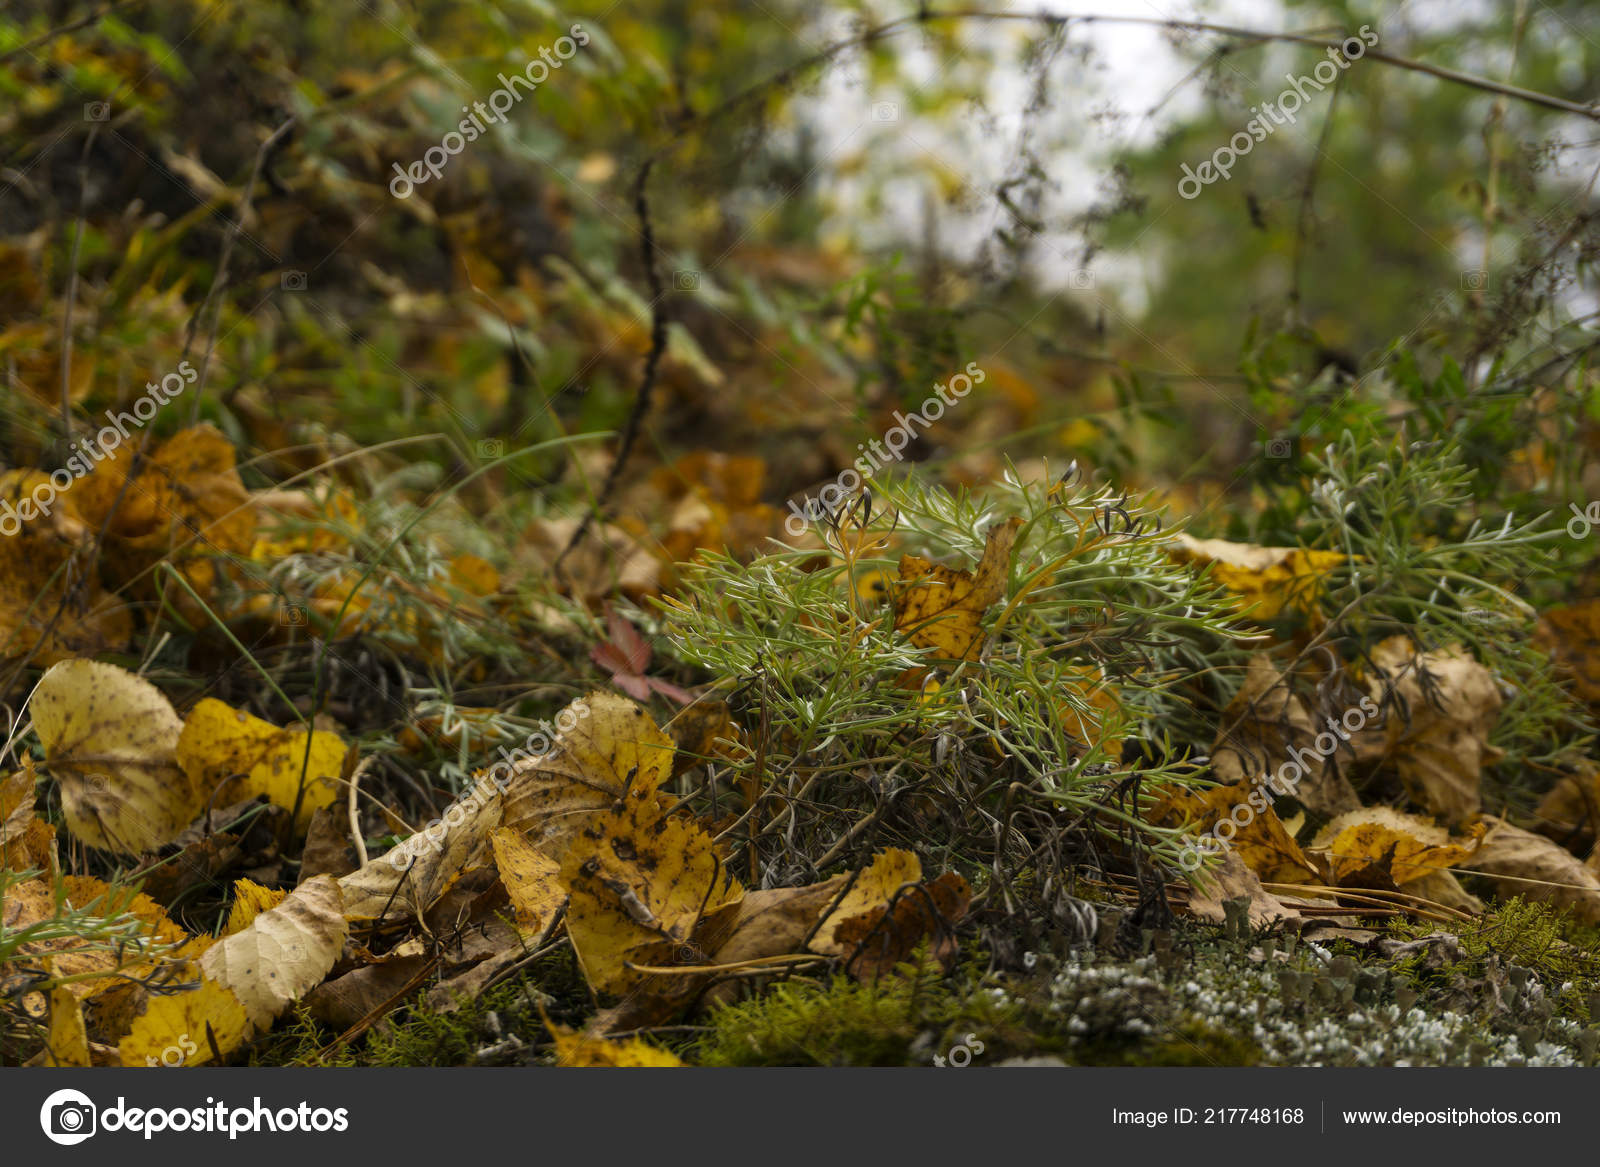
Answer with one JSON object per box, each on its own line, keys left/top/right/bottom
{"left": 1307, "top": 807, "right": 1485, "bottom": 887}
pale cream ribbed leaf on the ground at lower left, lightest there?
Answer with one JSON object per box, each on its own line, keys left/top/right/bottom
{"left": 200, "top": 876, "right": 349, "bottom": 1029}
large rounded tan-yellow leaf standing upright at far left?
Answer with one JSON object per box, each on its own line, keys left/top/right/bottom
{"left": 30, "top": 661, "right": 208, "bottom": 855}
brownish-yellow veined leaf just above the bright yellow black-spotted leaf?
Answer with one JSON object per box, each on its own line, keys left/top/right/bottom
{"left": 502, "top": 692, "right": 675, "bottom": 860}
